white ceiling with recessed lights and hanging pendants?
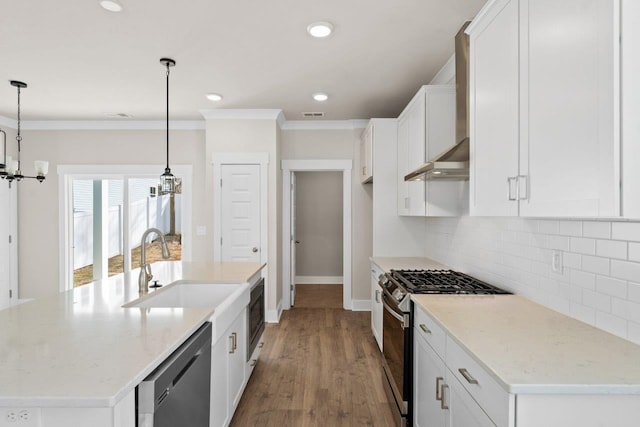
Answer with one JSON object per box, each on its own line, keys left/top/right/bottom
{"left": 0, "top": 0, "right": 485, "bottom": 120}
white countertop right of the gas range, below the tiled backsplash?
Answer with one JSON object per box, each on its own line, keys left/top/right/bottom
{"left": 412, "top": 295, "right": 640, "bottom": 394}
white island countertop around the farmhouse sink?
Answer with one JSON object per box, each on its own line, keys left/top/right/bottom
{"left": 0, "top": 262, "right": 264, "bottom": 407}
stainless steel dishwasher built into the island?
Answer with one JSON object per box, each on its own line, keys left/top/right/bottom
{"left": 138, "top": 322, "right": 211, "bottom": 427}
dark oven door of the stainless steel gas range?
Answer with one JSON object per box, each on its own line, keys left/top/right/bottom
{"left": 382, "top": 292, "right": 411, "bottom": 426}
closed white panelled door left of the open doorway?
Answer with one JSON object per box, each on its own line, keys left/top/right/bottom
{"left": 220, "top": 164, "right": 262, "bottom": 262}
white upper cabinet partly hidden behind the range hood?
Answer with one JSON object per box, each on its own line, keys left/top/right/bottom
{"left": 397, "top": 85, "right": 469, "bottom": 221}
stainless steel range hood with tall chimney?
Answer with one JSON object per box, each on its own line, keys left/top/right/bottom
{"left": 404, "top": 21, "right": 471, "bottom": 181}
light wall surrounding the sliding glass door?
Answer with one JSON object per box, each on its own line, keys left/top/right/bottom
{"left": 18, "top": 130, "right": 211, "bottom": 298}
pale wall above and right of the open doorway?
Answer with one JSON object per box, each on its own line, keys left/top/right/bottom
{"left": 281, "top": 129, "right": 373, "bottom": 300}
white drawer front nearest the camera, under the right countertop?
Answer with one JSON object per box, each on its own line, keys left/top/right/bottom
{"left": 446, "top": 337, "right": 512, "bottom": 426}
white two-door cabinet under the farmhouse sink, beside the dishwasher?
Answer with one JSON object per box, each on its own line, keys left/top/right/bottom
{"left": 210, "top": 308, "right": 247, "bottom": 427}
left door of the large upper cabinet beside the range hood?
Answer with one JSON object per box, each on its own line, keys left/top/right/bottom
{"left": 469, "top": 0, "right": 519, "bottom": 216}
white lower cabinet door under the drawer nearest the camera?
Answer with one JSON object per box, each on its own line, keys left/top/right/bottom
{"left": 444, "top": 372, "right": 495, "bottom": 427}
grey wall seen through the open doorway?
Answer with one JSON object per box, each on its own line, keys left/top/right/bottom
{"left": 296, "top": 172, "right": 342, "bottom": 276}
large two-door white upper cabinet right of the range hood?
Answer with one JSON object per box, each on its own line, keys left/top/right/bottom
{"left": 467, "top": 0, "right": 621, "bottom": 217}
